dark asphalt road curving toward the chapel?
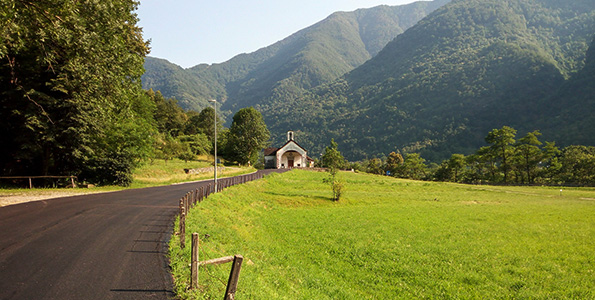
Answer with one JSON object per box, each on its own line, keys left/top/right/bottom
{"left": 0, "top": 170, "right": 284, "bottom": 300}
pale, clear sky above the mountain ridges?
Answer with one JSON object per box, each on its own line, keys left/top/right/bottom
{"left": 136, "top": 0, "right": 414, "bottom": 68}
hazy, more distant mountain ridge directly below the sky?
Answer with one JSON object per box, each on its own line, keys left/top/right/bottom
{"left": 142, "top": 0, "right": 449, "bottom": 111}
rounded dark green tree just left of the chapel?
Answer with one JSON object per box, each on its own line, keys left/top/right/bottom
{"left": 227, "top": 107, "right": 270, "bottom": 164}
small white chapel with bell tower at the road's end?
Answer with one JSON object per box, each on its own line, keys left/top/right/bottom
{"left": 264, "top": 131, "right": 314, "bottom": 169}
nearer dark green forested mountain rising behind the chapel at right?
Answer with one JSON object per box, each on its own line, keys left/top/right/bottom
{"left": 266, "top": 0, "right": 595, "bottom": 161}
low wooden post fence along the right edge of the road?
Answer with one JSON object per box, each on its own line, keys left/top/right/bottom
{"left": 179, "top": 173, "right": 263, "bottom": 299}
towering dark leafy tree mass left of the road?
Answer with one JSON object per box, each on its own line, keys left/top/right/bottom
{"left": 0, "top": 0, "right": 152, "bottom": 184}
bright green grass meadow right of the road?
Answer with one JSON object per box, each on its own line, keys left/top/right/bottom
{"left": 170, "top": 170, "right": 595, "bottom": 299}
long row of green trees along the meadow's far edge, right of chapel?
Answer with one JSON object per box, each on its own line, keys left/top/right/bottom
{"left": 353, "top": 126, "right": 595, "bottom": 186}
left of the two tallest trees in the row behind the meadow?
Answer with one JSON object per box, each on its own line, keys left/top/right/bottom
{"left": 485, "top": 126, "right": 516, "bottom": 183}
